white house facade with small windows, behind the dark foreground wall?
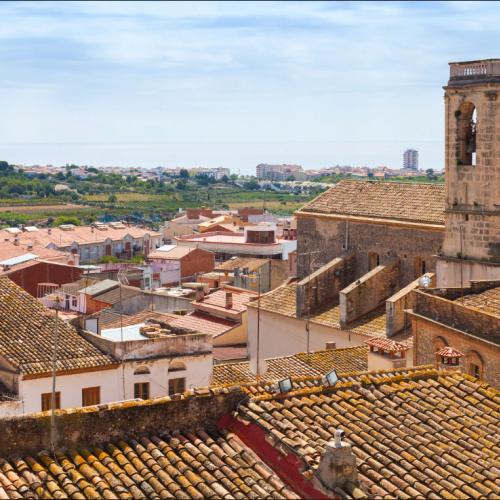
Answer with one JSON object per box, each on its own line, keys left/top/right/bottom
{"left": 16, "top": 354, "right": 213, "bottom": 417}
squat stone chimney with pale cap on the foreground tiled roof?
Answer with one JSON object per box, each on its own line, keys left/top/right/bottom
{"left": 315, "top": 429, "right": 359, "bottom": 492}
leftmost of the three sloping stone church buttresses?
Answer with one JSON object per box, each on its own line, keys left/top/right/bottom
{"left": 296, "top": 253, "right": 355, "bottom": 318}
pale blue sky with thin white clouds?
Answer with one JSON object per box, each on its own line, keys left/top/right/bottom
{"left": 0, "top": 1, "right": 500, "bottom": 174}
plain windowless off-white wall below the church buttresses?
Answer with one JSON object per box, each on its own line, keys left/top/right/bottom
{"left": 248, "top": 307, "right": 367, "bottom": 359}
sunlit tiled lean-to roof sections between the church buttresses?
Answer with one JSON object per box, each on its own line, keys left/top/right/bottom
{"left": 252, "top": 283, "right": 386, "bottom": 337}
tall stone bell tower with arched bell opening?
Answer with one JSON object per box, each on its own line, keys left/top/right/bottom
{"left": 436, "top": 59, "right": 500, "bottom": 287}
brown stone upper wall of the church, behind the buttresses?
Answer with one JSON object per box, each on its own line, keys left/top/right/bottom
{"left": 297, "top": 214, "right": 444, "bottom": 288}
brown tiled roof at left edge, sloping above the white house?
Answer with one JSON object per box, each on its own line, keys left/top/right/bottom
{"left": 0, "top": 277, "right": 116, "bottom": 375}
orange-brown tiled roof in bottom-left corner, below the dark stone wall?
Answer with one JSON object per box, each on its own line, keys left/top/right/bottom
{"left": 0, "top": 431, "right": 298, "bottom": 499}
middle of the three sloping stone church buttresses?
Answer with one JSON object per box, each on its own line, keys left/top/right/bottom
{"left": 339, "top": 259, "right": 400, "bottom": 325}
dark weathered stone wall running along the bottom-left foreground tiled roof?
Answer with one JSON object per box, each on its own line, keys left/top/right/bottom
{"left": 0, "top": 391, "right": 246, "bottom": 457}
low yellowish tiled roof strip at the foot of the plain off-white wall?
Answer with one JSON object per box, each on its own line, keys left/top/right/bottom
{"left": 212, "top": 346, "right": 368, "bottom": 385}
